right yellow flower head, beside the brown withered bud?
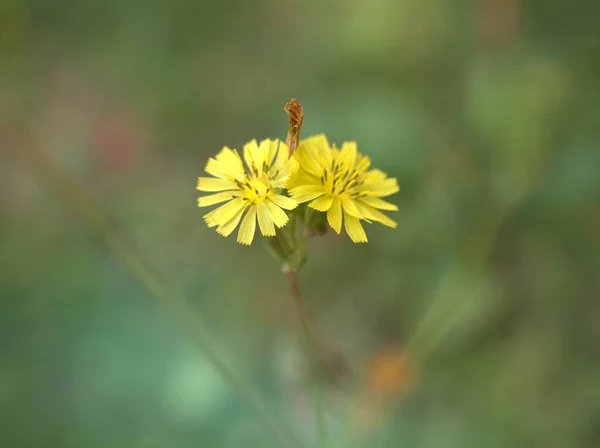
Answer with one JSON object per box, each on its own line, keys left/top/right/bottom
{"left": 288, "top": 134, "right": 400, "bottom": 243}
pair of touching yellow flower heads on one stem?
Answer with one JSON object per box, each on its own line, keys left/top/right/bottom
{"left": 197, "top": 134, "right": 400, "bottom": 245}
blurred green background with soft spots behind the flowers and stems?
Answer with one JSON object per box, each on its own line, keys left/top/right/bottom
{"left": 0, "top": 0, "right": 600, "bottom": 448}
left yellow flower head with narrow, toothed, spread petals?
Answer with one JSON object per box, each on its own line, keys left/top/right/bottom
{"left": 197, "top": 140, "right": 298, "bottom": 245}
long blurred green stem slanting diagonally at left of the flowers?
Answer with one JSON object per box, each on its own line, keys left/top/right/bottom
{"left": 8, "top": 139, "right": 303, "bottom": 448}
